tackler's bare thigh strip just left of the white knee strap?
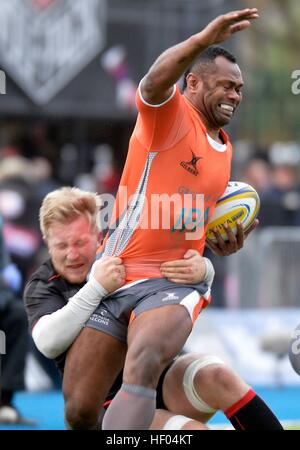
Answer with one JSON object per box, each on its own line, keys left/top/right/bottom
{"left": 162, "top": 353, "right": 214, "bottom": 423}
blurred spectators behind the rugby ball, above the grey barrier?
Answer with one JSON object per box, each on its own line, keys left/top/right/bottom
{"left": 207, "top": 142, "right": 300, "bottom": 307}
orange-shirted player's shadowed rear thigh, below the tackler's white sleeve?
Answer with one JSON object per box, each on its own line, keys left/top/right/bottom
{"left": 63, "top": 327, "right": 127, "bottom": 402}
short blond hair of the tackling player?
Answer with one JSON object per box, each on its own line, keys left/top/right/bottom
{"left": 39, "top": 187, "right": 101, "bottom": 238}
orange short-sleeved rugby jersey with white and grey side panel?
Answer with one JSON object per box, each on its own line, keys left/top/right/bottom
{"left": 100, "top": 86, "right": 232, "bottom": 282}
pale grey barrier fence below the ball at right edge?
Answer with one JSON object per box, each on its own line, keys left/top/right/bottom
{"left": 225, "top": 227, "right": 300, "bottom": 308}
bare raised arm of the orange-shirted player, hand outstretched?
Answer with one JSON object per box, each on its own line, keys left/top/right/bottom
{"left": 141, "top": 8, "right": 259, "bottom": 104}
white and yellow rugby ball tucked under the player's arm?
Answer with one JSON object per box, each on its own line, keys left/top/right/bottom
{"left": 206, "top": 181, "right": 260, "bottom": 242}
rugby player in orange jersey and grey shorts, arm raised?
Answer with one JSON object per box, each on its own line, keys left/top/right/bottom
{"left": 64, "top": 9, "right": 270, "bottom": 429}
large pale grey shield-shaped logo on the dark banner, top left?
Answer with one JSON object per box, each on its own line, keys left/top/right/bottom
{"left": 0, "top": 0, "right": 106, "bottom": 105}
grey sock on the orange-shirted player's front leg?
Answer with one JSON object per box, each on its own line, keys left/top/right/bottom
{"left": 102, "top": 384, "right": 156, "bottom": 430}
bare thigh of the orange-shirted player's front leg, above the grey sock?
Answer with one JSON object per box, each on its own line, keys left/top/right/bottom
{"left": 128, "top": 305, "right": 192, "bottom": 360}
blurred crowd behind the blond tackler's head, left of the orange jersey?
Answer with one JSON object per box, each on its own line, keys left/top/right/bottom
{"left": 0, "top": 136, "right": 119, "bottom": 289}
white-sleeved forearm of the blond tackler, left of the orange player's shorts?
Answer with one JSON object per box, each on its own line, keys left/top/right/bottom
{"left": 32, "top": 278, "right": 107, "bottom": 359}
